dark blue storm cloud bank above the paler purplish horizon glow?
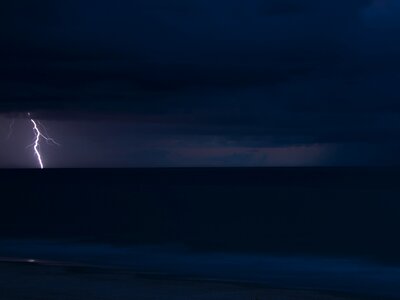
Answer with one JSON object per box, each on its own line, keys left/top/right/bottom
{"left": 0, "top": 0, "right": 400, "bottom": 159}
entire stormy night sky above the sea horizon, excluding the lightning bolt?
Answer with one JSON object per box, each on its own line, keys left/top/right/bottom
{"left": 0, "top": 0, "right": 400, "bottom": 167}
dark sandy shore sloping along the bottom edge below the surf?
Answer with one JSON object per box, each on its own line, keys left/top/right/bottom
{"left": 0, "top": 262, "right": 372, "bottom": 300}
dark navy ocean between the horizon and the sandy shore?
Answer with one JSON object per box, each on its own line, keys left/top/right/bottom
{"left": 0, "top": 168, "right": 400, "bottom": 298}
